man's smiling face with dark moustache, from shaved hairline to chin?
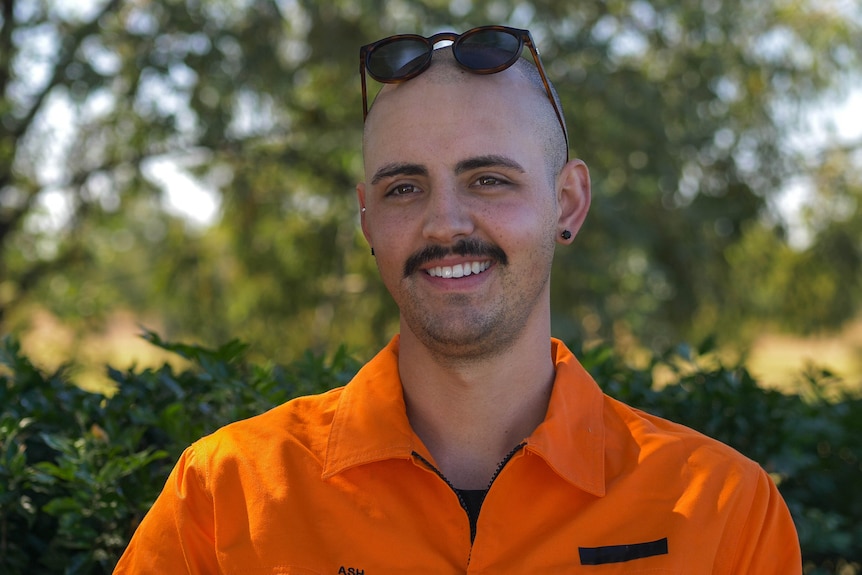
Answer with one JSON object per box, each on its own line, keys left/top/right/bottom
{"left": 358, "top": 66, "right": 560, "bottom": 358}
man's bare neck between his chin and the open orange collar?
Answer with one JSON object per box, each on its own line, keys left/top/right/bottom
{"left": 399, "top": 326, "right": 554, "bottom": 489}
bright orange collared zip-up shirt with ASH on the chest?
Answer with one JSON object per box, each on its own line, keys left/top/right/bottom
{"left": 115, "top": 337, "right": 802, "bottom": 575}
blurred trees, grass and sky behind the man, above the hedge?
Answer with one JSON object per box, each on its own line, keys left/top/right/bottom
{"left": 0, "top": 0, "right": 862, "bottom": 387}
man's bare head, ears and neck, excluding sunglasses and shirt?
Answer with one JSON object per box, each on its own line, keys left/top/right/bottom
{"left": 358, "top": 46, "right": 590, "bottom": 496}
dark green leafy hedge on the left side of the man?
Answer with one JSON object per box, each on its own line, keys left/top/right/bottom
{"left": 0, "top": 332, "right": 357, "bottom": 575}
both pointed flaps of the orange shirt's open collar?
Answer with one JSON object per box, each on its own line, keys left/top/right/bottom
{"left": 323, "top": 335, "right": 605, "bottom": 496}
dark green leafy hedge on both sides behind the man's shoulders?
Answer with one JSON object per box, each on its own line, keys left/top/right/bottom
{"left": 0, "top": 332, "right": 862, "bottom": 575}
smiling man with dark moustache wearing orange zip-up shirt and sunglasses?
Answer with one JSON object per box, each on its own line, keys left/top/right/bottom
{"left": 116, "top": 27, "right": 801, "bottom": 575}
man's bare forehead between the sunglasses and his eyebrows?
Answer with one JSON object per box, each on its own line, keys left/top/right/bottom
{"left": 364, "top": 67, "right": 541, "bottom": 168}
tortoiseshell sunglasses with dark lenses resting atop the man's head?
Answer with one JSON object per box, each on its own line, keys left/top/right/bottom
{"left": 359, "top": 26, "right": 569, "bottom": 155}
